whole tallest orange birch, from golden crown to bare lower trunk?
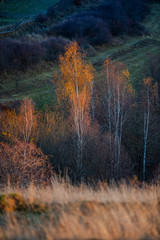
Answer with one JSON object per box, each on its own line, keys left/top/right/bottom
{"left": 57, "top": 42, "right": 94, "bottom": 175}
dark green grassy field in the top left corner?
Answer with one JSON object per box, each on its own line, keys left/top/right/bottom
{"left": 0, "top": 0, "right": 59, "bottom": 25}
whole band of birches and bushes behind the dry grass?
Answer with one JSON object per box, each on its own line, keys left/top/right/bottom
{"left": 0, "top": 42, "right": 160, "bottom": 185}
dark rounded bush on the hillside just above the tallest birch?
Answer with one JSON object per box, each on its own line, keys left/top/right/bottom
{"left": 49, "top": 16, "right": 111, "bottom": 45}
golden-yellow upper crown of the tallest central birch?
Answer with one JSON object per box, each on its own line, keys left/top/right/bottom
{"left": 57, "top": 42, "right": 94, "bottom": 106}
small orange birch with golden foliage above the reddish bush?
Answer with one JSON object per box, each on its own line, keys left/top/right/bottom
{"left": 1, "top": 98, "right": 38, "bottom": 143}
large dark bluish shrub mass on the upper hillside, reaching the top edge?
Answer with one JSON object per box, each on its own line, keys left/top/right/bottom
{"left": 49, "top": 0, "right": 147, "bottom": 45}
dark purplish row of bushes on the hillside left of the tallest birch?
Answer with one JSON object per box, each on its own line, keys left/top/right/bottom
{"left": 0, "top": 37, "right": 69, "bottom": 72}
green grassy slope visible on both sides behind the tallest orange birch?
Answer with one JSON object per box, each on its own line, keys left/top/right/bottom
{"left": 0, "top": 1, "right": 160, "bottom": 107}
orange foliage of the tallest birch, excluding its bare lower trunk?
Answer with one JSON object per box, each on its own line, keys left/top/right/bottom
{"left": 57, "top": 42, "right": 94, "bottom": 134}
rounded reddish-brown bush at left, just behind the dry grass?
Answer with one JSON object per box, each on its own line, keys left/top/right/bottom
{"left": 0, "top": 140, "right": 53, "bottom": 186}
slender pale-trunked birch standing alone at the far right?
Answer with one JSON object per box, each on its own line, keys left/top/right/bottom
{"left": 142, "top": 78, "right": 158, "bottom": 182}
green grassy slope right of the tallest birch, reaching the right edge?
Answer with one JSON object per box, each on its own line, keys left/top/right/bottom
{"left": 91, "top": 4, "right": 160, "bottom": 90}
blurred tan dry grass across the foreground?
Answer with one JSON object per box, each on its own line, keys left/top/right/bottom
{"left": 0, "top": 179, "right": 160, "bottom": 240}
